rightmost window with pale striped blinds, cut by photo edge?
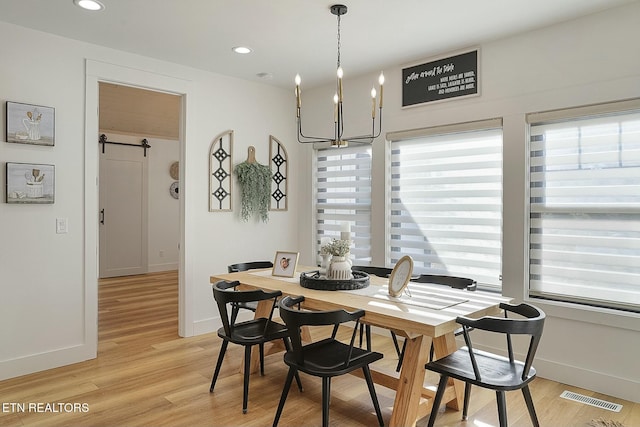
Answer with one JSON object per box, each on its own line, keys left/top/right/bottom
{"left": 527, "top": 100, "right": 640, "bottom": 311}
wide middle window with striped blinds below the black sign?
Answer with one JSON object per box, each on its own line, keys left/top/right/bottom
{"left": 387, "top": 119, "right": 502, "bottom": 288}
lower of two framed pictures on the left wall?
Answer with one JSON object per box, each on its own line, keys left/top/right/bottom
{"left": 5, "top": 162, "right": 56, "bottom": 204}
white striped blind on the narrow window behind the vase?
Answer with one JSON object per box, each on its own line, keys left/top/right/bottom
{"left": 316, "top": 144, "right": 371, "bottom": 262}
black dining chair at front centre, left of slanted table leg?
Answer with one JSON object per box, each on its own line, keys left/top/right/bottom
{"left": 273, "top": 296, "right": 384, "bottom": 427}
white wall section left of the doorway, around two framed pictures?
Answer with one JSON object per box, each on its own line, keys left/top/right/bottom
{"left": 0, "top": 24, "right": 89, "bottom": 378}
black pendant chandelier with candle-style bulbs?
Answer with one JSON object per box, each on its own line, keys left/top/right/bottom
{"left": 295, "top": 4, "right": 384, "bottom": 147}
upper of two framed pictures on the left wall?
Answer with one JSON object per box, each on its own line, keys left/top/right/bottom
{"left": 6, "top": 101, "right": 56, "bottom": 146}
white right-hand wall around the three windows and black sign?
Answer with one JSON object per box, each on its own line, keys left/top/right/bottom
{"left": 300, "top": 2, "right": 640, "bottom": 402}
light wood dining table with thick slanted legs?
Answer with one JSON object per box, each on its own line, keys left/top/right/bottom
{"left": 210, "top": 266, "right": 511, "bottom": 427}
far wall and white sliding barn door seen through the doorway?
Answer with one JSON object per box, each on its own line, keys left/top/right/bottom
{"left": 99, "top": 82, "right": 181, "bottom": 278}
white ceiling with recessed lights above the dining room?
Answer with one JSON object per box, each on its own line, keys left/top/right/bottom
{"left": 0, "top": 0, "right": 638, "bottom": 87}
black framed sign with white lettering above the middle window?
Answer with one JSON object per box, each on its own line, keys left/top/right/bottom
{"left": 402, "top": 49, "right": 479, "bottom": 107}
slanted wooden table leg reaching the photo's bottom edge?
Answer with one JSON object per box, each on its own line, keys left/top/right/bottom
{"left": 389, "top": 335, "right": 431, "bottom": 427}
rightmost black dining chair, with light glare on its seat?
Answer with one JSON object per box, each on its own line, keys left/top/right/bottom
{"left": 425, "top": 303, "right": 545, "bottom": 427}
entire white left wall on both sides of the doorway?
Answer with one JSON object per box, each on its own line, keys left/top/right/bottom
{"left": 0, "top": 23, "right": 299, "bottom": 379}
